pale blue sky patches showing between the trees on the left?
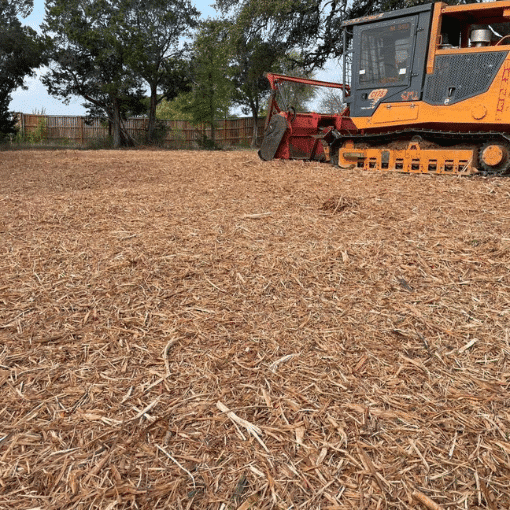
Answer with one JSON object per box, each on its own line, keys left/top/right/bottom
{"left": 9, "top": 0, "right": 216, "bottom": 115}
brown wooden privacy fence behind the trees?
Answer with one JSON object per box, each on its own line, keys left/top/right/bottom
{"left": 17, "top": 113, "right": 265, "bottom": 149}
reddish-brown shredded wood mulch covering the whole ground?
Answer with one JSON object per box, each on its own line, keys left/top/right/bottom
{"left": 0, "top": 151, "right": 510, "bottom": 510}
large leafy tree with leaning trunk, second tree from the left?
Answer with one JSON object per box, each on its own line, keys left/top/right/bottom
{"left": 43, "top": 0, "right": 141, "bottom": 147}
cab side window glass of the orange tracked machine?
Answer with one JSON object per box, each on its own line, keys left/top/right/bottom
{"left": 359, "top": 21, "right": 413, "bottom": 87}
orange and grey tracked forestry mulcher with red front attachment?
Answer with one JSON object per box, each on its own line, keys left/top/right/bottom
{"left": 259, "top": 0, "right": 510, "bottom": 175}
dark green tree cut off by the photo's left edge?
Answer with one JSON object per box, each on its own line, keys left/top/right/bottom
{"left": 0, "top": 0, "right": 44, "bottom": 140}
